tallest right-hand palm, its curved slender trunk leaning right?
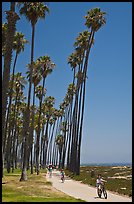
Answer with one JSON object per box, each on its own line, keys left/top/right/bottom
{"left": 76, "top": 8, "right": 106, "bottom": 174}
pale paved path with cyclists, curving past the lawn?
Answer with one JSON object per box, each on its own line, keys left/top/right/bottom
{"left": 46, "top": 170, "right": 132, "bottom": 202}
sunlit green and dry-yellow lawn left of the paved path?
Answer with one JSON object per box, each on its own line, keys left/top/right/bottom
{"left": 2, "top": 170, "right": 84, "bottom": 202}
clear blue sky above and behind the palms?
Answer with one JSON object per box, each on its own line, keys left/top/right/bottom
{"left": 2, "top": 2, "right": 132, "bottom": 163}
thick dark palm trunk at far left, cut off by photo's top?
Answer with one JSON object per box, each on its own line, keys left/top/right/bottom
{"left": 2, "top": 2, "right": 19, "bottom": 175}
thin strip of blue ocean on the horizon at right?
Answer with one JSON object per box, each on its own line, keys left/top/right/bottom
{"left": 80, "top": 163, "right": 132, "bottom": 167}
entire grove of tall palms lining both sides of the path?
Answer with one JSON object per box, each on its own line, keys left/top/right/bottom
{"left": 2, "top": 2, "right": 105, "bottom": 181}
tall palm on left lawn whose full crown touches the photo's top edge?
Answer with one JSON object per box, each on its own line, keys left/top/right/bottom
{"left": 18, "top": 2, "right": 49, "bottom": 181}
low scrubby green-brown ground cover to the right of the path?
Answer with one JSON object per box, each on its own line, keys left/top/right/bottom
{"left": 65, "top": 166, "right": 132, "bottom": 197}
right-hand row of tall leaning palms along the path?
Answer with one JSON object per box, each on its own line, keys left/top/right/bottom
{"left": 51, "top": 8, "right": 106, "bottom": 175}
